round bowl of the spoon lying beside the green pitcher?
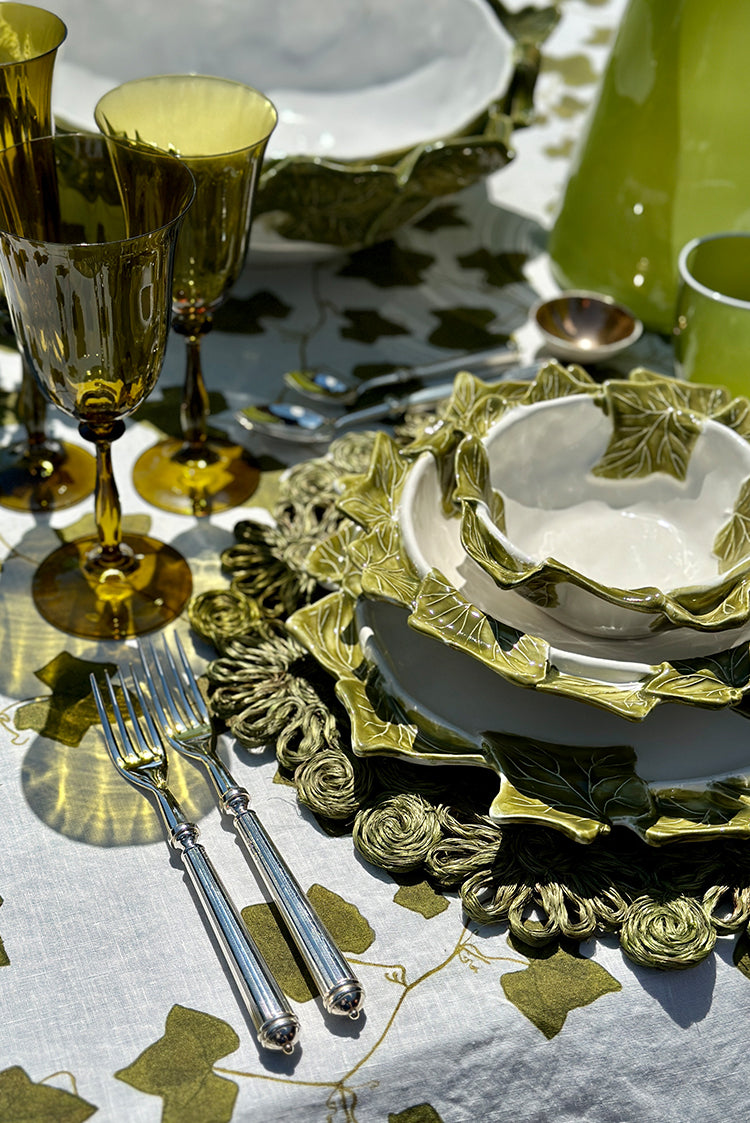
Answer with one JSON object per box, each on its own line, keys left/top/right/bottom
{"left": 531, "top": 290, "right": 643, "bottom": 363}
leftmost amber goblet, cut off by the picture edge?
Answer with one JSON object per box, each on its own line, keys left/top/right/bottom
{"left": 0, "top": 3, "right": 94, "bottom": 511}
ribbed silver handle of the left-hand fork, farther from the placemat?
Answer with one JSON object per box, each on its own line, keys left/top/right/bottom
{"left": 170, "top": 823, "right": 300, "bottom": 1053}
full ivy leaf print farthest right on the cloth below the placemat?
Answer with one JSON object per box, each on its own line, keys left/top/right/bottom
{"left": 500, "top": 941, "right": 622, "bottom": 1040}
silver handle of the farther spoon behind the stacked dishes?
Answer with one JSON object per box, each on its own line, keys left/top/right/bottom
{"left": 284, "top": 347, "right": 519, "bottom": 405}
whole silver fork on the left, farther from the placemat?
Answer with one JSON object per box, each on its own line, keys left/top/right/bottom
{"left": 90, "top": 674, "right": 300, "bottom": 1053}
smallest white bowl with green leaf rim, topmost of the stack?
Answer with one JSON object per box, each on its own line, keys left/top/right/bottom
{"left": 401, "top": 366, "right": 750, "bottom": 638}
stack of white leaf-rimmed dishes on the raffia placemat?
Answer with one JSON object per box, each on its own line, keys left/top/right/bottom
{"left": 289, "top": 363, "right": 750, "bottom": 843}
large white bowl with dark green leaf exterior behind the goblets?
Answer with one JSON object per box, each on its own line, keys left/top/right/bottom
{"left": 53, "top": 0, "right": 541, "bottom": 261}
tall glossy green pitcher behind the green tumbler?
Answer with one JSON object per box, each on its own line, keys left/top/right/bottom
{"left": 549, "top": 0, "right": 750, "bottom": 331}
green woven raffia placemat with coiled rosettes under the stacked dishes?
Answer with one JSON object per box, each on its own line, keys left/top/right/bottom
{"left": 190, "top": 417, "right": 750, "bottom": 969}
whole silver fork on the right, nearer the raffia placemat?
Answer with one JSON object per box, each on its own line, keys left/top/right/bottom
{"left": 138, "top": 636, "right": 365, "bottom": 1019}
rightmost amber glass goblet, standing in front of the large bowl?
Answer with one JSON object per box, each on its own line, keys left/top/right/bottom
{"left": 94, "top": 74, "right": 276, "bottom": 515}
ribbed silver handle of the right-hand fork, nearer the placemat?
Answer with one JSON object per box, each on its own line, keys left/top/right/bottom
{"left": 221, "top": 787, "right": 365, "bottom": 1019}
